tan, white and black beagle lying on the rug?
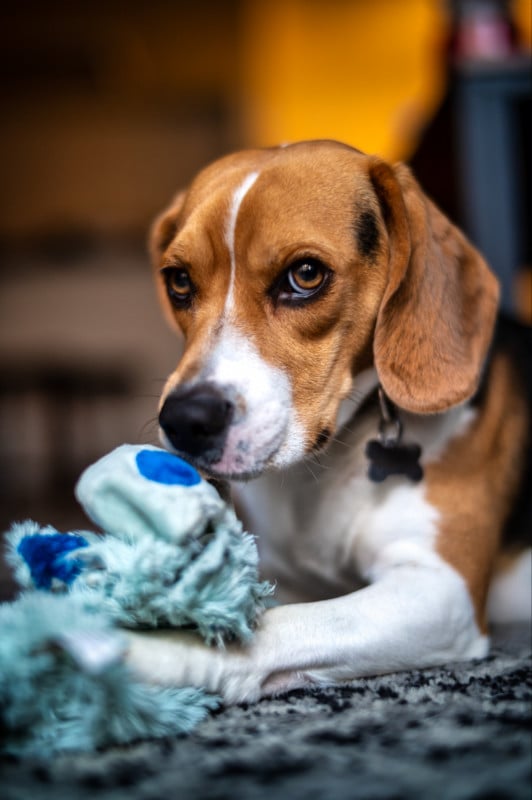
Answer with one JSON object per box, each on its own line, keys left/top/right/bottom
{"left": 125, "top": 141, "right": 531, "bottom": 703}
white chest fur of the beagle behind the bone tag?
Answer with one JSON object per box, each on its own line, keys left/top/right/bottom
{"left": 238, "top": 407, "right": 474, "bottom": 602}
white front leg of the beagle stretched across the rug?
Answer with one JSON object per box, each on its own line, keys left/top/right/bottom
{"left": 124, "top": 562, "right": 488, "bottom": 703}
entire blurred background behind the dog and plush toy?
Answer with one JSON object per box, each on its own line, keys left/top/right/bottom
{"left": 0, "top": 0, "right": 532, "bottom": 596}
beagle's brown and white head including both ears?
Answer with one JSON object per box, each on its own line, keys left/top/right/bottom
{"left": 151, "top": 142, "right": 498, "bottom": 478}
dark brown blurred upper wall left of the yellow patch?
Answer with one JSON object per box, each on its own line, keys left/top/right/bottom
{"left": 0, "top": 0, "right": 238, "bottom": 237}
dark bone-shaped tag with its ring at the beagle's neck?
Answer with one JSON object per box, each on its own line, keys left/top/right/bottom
{"left": 366, "top": 386, "right": 423, "bottom": 483}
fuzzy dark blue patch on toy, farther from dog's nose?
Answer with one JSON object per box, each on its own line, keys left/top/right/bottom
{"left": 17, "top": 533, "right": 89, "bottom": 589}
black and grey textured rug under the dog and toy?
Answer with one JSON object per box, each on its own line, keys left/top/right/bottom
{"left": 0, "top": 626, "right": 532, "bottom": 800}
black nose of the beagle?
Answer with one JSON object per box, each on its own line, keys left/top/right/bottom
{"left": 159, "top": 383, "right": 234, "bottom": 464}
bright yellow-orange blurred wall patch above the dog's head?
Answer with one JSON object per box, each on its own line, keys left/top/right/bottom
{"left": 239, "top": 0, "right": 448, "bottom": 159}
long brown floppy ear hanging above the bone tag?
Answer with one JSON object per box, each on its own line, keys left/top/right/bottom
{"left": 370, "top": 159, "right": 498, "bottom": 414}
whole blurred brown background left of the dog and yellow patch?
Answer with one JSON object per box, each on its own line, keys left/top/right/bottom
{"left": 0, "top": 0, "right": 241, "bottom": 552}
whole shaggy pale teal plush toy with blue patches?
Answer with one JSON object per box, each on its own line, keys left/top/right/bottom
{"left": 0, "top": 445, "right": 272, "bottom": 757}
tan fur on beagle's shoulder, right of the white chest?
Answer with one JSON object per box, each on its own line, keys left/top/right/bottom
{"left": 426, "top": 355, "right": 527, "bottom": 631}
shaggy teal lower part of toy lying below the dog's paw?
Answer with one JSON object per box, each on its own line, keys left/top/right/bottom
{"left": 0, "top": 592, "right": 219, "bottom": 759}
